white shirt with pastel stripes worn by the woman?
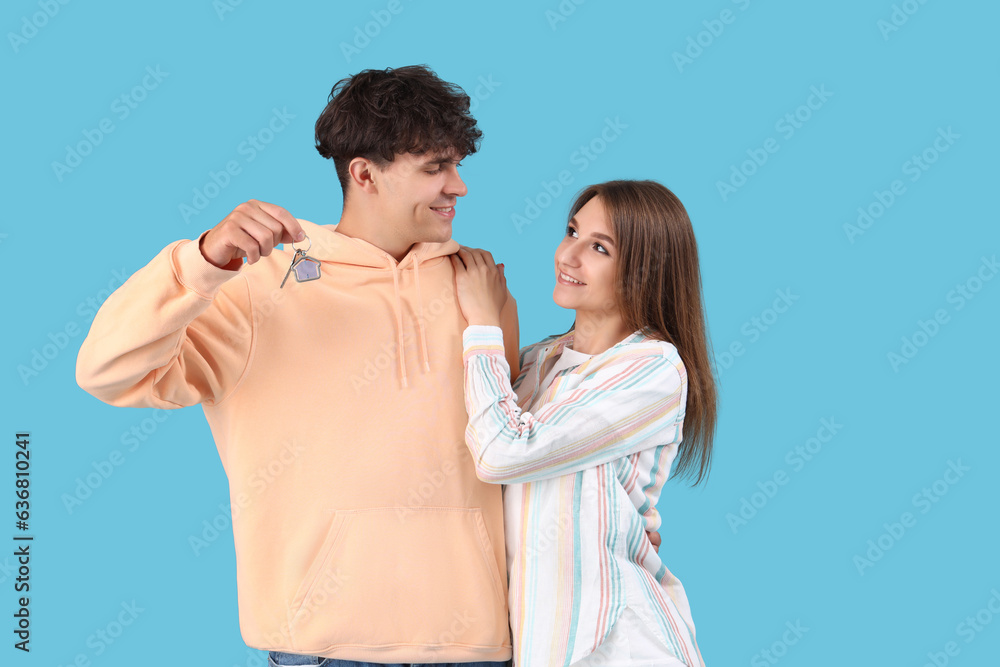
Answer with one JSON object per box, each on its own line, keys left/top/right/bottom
{"left": 463, "top": 326, "right": 703, "bottom": 667}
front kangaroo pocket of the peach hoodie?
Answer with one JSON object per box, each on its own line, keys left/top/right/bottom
{"left": 289, "top": 507, "right": 510, "bottom": 653}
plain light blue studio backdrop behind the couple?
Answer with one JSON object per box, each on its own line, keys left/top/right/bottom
{"left": 0, "top": 0, "right": 1000, "bottom": 667}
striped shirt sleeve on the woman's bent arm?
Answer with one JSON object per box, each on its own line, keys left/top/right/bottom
{"left": 463, "top": 326, "right": 686, "bottom": 484}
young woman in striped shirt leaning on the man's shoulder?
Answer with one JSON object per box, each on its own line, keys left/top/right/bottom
{"left": 452, "top": 181, "right": 716, "bottom": 667}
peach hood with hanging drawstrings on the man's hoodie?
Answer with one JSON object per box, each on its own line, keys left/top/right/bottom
{"left": 285, "top": 218, "right": 461, "bottom": 388}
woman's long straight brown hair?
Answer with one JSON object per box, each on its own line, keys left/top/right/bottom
{"left": 569, "top": 180, "right": 718, "bottom": 486}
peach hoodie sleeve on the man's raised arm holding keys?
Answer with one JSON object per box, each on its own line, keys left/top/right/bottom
{"left": 76, "top": 239, "right": 253, "bottom": 409}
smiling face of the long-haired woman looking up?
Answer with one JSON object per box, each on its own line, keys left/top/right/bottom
{"left": 552, "top": 197, "right": 618, "bottom": 314}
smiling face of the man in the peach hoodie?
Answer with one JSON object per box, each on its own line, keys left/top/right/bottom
{"left": 374, "top": 149, "right": 468, "bottom": 243}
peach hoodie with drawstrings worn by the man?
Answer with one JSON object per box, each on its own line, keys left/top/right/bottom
{"left": 77, "top": 220, "right": 518, "bottom": 662}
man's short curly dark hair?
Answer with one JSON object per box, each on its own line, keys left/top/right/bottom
{"left": 316, "top": 65, "right": 483, "bottom": 199}
